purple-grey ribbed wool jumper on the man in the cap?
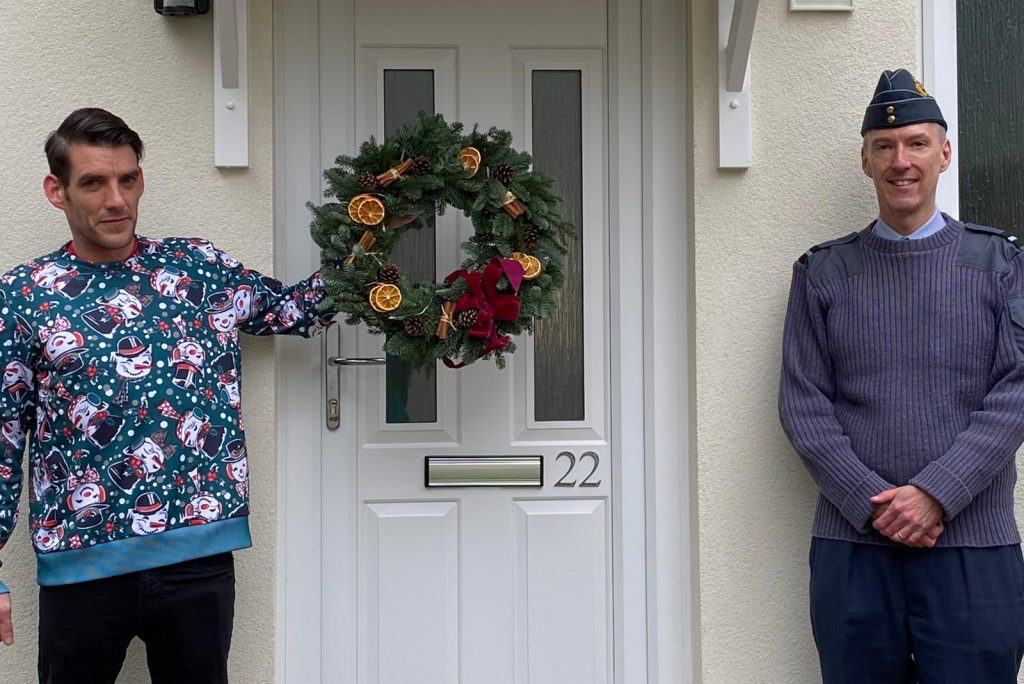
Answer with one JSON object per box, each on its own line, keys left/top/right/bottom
{"left": 779, "top": 216, "right": 1024, "bottom": 547}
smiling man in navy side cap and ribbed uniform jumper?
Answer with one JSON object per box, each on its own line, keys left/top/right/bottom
{"left": 779, "top": 70, "right": 1024, "bottom": 684}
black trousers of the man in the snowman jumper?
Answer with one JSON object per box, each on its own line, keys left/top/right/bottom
{"left": 39, "top": 553, "right": 234, "bottom": 684}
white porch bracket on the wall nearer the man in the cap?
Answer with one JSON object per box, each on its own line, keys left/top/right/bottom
{"left": 718, "top": 0, "right": 759, "bottom": 169}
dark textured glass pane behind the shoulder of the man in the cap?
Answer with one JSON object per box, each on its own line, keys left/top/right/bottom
{"left": 954, "top": 0, "right": 1024, "bottom": 237}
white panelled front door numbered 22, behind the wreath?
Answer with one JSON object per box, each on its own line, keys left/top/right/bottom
{"left": 321, "top": 0, "right": 614, "bottom": 684}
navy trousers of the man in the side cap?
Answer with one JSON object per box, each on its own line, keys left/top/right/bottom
{"left": 810, "top": 539, "right": 1024, "bottom": 684}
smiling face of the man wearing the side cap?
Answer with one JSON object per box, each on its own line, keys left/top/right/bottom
{"left": 860, "top": 123, "right": 951, "bottom": 231}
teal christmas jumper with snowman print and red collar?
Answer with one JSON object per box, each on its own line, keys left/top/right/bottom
{"left": 0, "top": 238, "right": 331, "bottom": 591}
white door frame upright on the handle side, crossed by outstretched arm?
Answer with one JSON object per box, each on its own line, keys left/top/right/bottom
{"left": 273, "top": 0, "right": 324, "bottom": 682}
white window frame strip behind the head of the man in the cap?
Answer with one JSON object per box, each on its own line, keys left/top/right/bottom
{"left": 918, "top": 0, "right": 959, "bottom": 218}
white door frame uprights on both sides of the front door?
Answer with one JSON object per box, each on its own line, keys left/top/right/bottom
{"left": 273, "top": 0, "right": 698, "bottom": 684}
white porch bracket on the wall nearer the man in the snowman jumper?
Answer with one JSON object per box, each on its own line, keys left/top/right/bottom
{"left": 213, "top": 0, "right": 249, "bottom": 168}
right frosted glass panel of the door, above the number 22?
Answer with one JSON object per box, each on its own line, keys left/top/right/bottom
{"left": 532, "top": 71, "right": 585, "bottom": 421}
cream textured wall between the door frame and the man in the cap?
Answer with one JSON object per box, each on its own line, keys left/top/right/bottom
{"left": 691, "top": 0, "right": 918, "bottom": 684}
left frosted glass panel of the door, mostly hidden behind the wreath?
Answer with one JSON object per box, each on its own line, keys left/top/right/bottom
{"left": 384, "top": 69, "right": 437, "bottom": 423}
